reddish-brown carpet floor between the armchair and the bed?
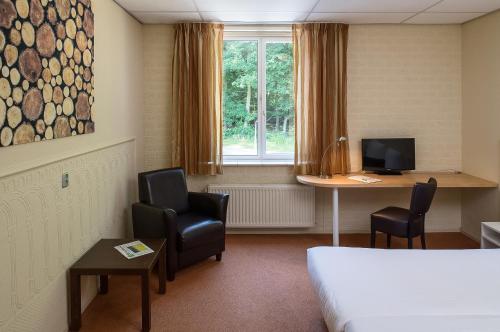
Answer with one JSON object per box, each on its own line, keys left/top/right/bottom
{"left": 81, "top": 233, "right": 478, "bottom": 332}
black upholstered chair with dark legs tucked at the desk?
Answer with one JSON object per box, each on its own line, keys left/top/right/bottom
{"left": 371, "top": 178, "right": 437, "bottom": 249}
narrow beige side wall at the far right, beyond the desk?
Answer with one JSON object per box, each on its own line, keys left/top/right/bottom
{"left": 462, "top": 11, "right": 500, "bottom": 239}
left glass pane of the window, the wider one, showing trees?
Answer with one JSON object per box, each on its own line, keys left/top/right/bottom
{"left": 223, "top": 40, "right": 258, "bottom": 156}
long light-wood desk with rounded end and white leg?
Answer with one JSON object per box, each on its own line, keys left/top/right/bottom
{"left": 297, "top": 172, "right": 498, "bottom": 246}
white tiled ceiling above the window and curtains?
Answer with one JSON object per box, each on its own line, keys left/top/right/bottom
{"left": 115, "top": 0, "right": 500, "bottom": 24}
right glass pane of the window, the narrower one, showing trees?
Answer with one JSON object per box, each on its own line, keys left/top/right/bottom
{"left": 266, "top": 42, "right": 295, "bottom": 154}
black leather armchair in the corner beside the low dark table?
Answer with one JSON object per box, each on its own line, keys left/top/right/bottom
{"left": 132, "top": 168, "right": 229, "bottom": 281}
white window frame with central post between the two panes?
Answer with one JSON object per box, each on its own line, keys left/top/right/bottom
{"left": 223, "top": 27, "right": 295, "bottom": 164}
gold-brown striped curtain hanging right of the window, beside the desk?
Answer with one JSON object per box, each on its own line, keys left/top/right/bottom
{"left": 292, "top": 23, "right": 350, "bottom": 175}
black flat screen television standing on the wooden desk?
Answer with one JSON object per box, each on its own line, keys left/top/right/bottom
{"left": 361, "top": 138, "right": 415, "bottom": 175}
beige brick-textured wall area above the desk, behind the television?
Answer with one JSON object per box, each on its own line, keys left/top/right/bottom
{"left": 347, "top": 25, "right": 462, "bottom": 171}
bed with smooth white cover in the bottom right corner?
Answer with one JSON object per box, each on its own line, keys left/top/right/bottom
{"left": 307, "top": 247, "right": 500, "bottom": 332}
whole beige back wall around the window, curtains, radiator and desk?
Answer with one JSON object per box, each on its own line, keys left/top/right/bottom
{"left": 144, "top": 25, "right": 462, "bottom": 233}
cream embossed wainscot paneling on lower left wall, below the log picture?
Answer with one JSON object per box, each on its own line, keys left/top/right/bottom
{"left": 0, "top": 141, "right": 136, "bottom": 331}
